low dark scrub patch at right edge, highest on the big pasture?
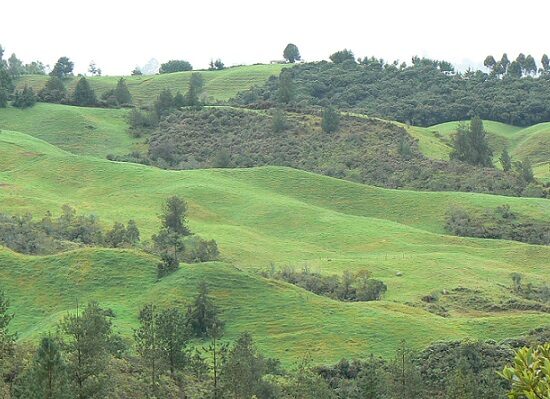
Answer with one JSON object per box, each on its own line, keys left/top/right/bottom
{"left": 445, "top": 206, "right": 550, "bottom": 245}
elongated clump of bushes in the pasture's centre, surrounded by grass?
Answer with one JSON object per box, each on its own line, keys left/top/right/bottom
{"left": 262, "top": 266, "right": 388, "bottom": 302}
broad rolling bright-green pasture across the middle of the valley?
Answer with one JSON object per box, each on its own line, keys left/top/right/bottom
{"left": 0, "top": 131, "right": 550, "bottom": 362}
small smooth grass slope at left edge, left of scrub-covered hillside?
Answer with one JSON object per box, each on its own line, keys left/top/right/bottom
{"left": 0, "top": 103, "right": 137, "bottom": 158}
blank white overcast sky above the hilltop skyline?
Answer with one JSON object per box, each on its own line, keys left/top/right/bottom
{"left": 0, "top": 0, "right": 550, "bottom": 75}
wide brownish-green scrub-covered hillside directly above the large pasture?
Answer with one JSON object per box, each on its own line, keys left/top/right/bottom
{"left": 147, "top": 108, "right": 542, "bottom": 195}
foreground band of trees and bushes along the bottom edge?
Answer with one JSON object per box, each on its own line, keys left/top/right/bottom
{"left": 0, "top": 283, "right": 550, "bottom": 399}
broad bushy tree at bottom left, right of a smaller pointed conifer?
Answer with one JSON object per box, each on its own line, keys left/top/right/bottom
{"left": 60, "top": 302, "right": 111, "bottom": 399}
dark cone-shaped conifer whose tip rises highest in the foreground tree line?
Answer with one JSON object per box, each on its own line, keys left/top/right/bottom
{"left": 187, "top": 281, "right": 223, "bottom": 337}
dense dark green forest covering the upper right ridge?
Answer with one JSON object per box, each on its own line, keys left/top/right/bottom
{"left": 236, "top": 56, "right": 550, "bottom": 126}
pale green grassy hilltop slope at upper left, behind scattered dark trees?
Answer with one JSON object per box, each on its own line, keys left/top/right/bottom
{"left": 17, "top": 64, "right": 285, "bottom": 105}
